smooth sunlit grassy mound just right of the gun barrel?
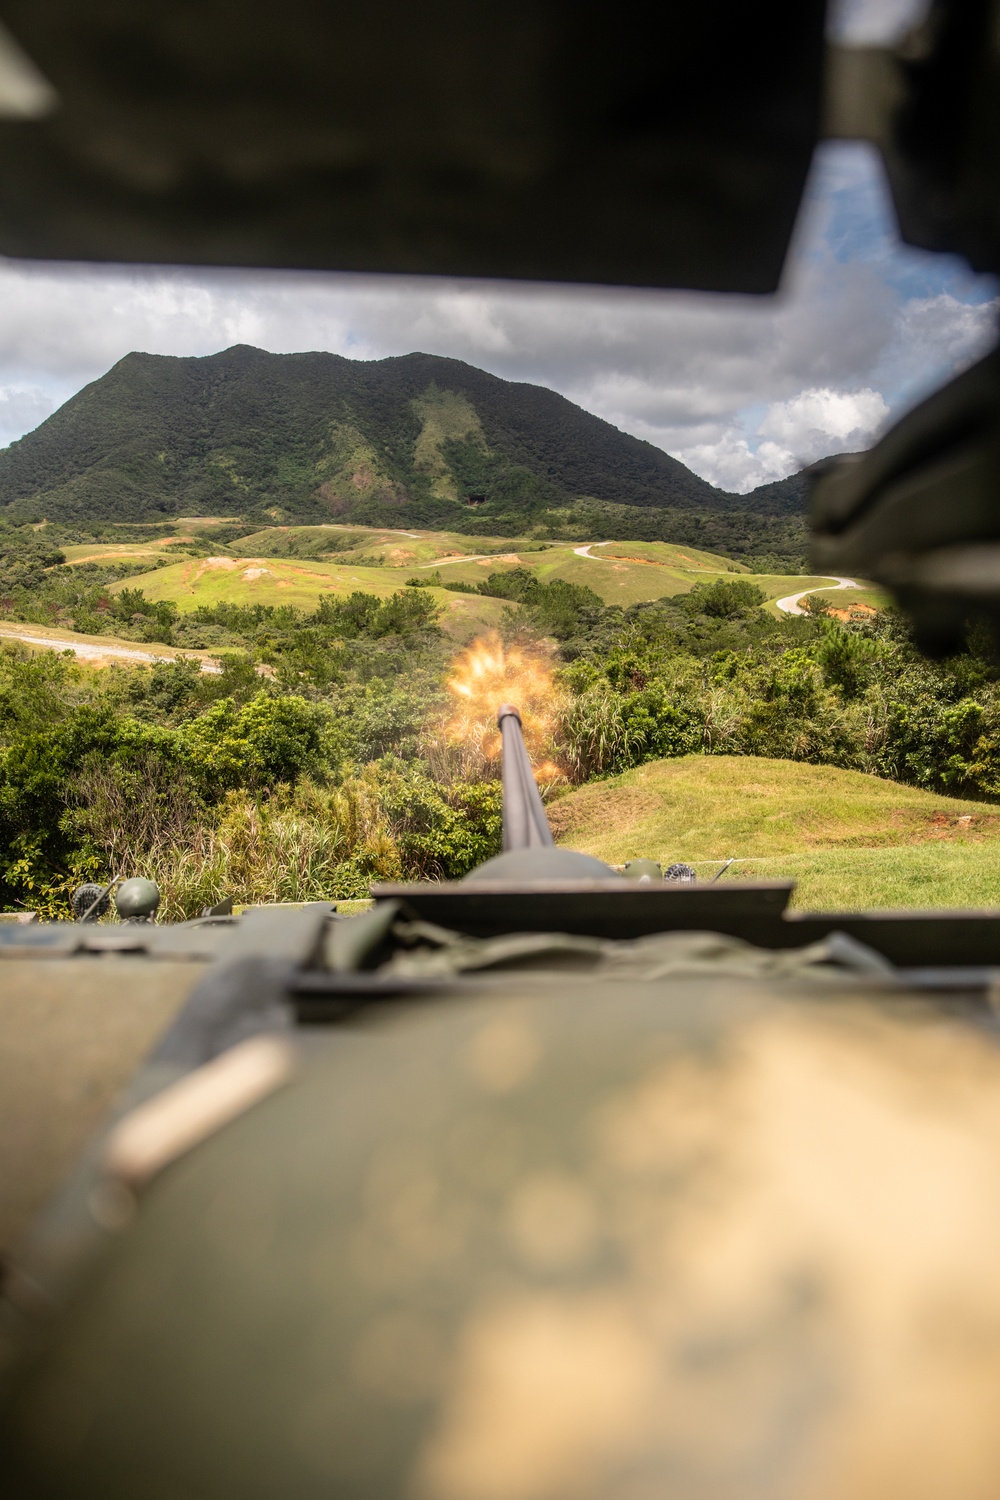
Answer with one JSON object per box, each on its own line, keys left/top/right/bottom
{"left": 550, "top": 756, "right": 1000, "bottom": 909}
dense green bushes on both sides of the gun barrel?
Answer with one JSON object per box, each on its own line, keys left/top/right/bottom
{"left": 0, "top": 534, "right": 1000, "bottom": 917}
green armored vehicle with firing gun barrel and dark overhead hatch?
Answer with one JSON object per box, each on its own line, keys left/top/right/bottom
{"left": 7, "top": 0, "right": 1000, "bottom": 1500}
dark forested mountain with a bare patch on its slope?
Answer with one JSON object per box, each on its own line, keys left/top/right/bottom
{"left": 0, "top": 345, "right": 803, "bottom": 530}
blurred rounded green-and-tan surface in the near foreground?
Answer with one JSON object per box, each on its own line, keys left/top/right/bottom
{"left": 3, "top": 956, "right": 1000, "bottom": 1500}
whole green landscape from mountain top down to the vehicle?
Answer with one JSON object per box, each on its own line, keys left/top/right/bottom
{"left": 0, "top": 363, "right": 1000, "bottom": 917}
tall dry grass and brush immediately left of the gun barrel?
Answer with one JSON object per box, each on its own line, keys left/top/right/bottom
{"left": 67, "top": 758, "right": 499, "bottom": 921}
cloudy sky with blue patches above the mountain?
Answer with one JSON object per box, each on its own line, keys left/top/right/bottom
{"left": 0, "top": 0, "right": 1000, "bottom": 494}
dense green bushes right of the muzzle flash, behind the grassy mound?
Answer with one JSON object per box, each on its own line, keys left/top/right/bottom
{"left": 562, "top": 603, "right": 1000, "bottom": 798}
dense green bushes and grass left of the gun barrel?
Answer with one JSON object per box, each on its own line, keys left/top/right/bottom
{"left": 0, "top": 630, "right": 499, "bottom": 917}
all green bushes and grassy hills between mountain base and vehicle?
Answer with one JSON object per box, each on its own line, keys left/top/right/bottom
{"left": 0, "top": 504, "right": 1000, "bottom": 917}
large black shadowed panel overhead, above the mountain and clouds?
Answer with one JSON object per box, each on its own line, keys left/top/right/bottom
{"left": 0, "top": 0, "right": 823, "bottom": 291}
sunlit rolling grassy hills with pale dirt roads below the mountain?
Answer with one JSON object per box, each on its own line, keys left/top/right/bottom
{"left": 0, "top": 518, "right": 888, "bottom": 672}
